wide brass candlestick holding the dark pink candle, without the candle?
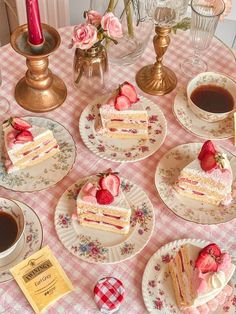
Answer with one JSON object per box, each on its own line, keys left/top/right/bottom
{"left": 11, "top": 24, "right": 67, "bottom": 112}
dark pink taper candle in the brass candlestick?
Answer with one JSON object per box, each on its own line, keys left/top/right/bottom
{"left": 25, "top": 0, "right": 44, "bottom": 45}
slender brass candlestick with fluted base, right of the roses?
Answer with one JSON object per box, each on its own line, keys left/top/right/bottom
{"left": 136, "top": 26, "right": 177, "bottom": 95}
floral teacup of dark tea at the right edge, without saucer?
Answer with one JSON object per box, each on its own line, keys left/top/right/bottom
{"left": 187, "top": 72, "right": 236, "bottom": 122}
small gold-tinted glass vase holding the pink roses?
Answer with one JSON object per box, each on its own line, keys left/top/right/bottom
{"left": 74, "top": 44, "right": 108, "bottom": 94}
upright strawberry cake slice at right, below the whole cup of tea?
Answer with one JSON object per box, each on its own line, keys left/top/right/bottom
{"left": 175, "top": 141, "right": 233, "bottom": 206}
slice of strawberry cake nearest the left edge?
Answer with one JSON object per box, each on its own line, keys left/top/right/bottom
{"left": 2, "top": 118, "right": 59, "bottom": 173}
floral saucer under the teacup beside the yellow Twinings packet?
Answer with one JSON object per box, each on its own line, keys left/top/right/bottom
{"left": 0, "top": 199, "right": 43, "bottom": 284}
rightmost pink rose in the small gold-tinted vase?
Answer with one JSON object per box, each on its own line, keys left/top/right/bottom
{"left": 101, "top": 12, "right": 123, "bottom": 38}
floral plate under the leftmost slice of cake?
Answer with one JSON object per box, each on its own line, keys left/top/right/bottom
{"left": 0, "top": 117, "right": 76, "bottom": 192}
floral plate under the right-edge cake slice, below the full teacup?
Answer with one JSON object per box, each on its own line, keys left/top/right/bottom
{"left": 155, "top": 143, "right": 236, "bottom": 224}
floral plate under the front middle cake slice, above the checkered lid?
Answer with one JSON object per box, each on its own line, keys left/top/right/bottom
{"left": 54, "top": 178, "right": 155, "bottom": 264}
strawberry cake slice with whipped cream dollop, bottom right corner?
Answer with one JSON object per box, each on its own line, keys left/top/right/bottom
{"left": 168, "top": 243, "right": 235, "bottom": 314}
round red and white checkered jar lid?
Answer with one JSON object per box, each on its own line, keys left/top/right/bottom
{"left": 93, "top": 277, "right": 125, "bottom": 314}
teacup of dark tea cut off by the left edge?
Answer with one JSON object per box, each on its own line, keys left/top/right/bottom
{"left": 0, "top": 197, "right": 25, "bottom": 259}
